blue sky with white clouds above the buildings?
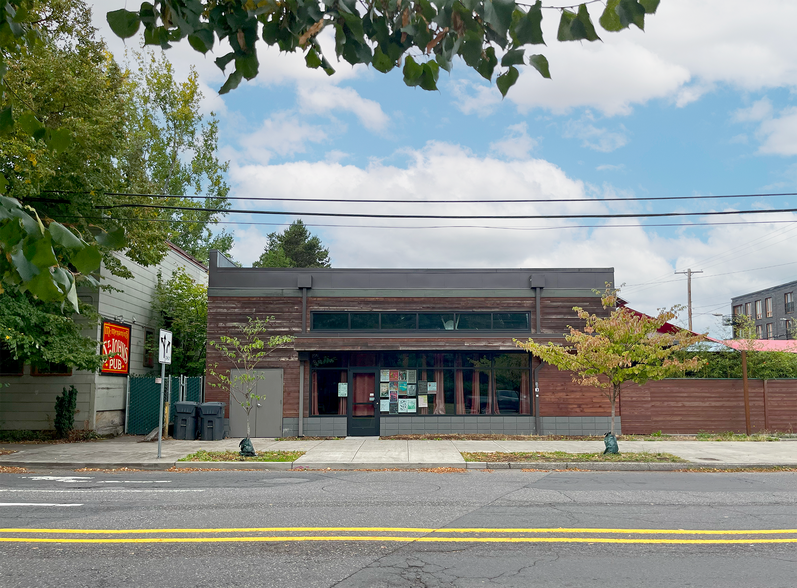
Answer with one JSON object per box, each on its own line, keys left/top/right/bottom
{"left": 92, "top": 0, "right": 797, "bottom": 337}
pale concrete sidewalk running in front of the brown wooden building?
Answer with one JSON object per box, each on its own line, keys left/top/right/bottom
{"left": 0, "top": 436, "right": 797, "bottom": 470}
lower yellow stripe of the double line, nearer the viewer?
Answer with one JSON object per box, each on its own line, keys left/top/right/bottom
{"left": 0, "top": 536, "right": 797, "bottom": 545}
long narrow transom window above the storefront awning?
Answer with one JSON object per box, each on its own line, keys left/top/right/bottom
{"left": 311, "top": 312, "right": 530, "bottom": 331}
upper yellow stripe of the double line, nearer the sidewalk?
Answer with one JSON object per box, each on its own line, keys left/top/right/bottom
{"left": 0, "top": 527, "right": 797, "bottom": 535}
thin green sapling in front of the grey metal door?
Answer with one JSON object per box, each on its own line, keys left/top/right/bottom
{"left": 208, "top": 316, "right": 293, "bottom": 439}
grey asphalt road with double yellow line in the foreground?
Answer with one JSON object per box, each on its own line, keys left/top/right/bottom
{"left": 0, "top": 470, "right": 797, "bottom": 588}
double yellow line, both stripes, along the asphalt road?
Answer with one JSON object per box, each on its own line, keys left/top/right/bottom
{"left": 0, "top": 527, "right": 797, "bottom": 545}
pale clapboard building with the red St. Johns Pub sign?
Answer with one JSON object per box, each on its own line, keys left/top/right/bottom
{"left": 0, "top": 244, "right": 208, "bottom": 434}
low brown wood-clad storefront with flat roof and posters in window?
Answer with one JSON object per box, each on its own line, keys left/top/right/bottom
{"left": 206, "top": 252, "right": 614, "bottom": 437}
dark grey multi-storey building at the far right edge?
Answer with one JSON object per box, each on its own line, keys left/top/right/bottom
{"left": 731, "top": 281, "right": 797, "bottom": 339}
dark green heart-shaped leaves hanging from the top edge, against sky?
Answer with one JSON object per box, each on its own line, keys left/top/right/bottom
{"left": 107, "top": 0, "right": 659, "bottom": 96}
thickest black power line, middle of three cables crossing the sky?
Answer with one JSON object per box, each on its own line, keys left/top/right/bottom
{"left": 94, "top": 203, "right": 797, "bottom": 220}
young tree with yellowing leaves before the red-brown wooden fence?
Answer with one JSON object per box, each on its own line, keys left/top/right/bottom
{"left": 515, "top": 288, "right": 704, "bottom": 433}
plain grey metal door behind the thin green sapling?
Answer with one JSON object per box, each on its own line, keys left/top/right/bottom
{"left": 230, "top": 369, "right": 282, "bottom": 437}
